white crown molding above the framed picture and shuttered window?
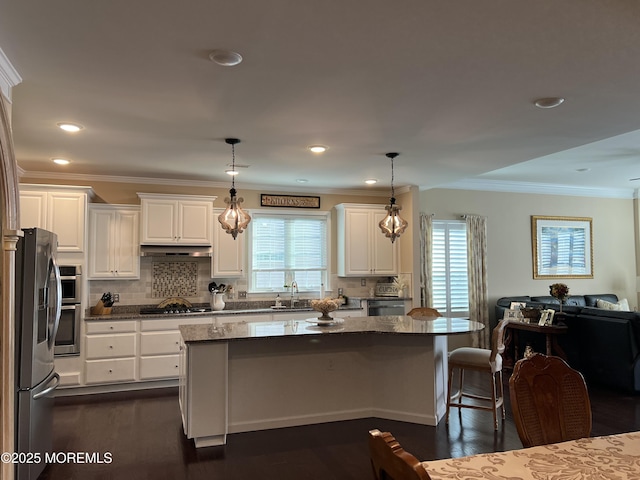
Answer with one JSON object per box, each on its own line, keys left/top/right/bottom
{"left": 432, "top": 178, "right": 638, "bottom": 199}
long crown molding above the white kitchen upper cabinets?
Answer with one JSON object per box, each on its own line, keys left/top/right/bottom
{"left": 18, "top": 169, "right": 390, "bottom": 197}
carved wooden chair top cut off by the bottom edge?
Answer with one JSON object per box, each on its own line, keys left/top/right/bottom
{"left": 369, "top": 430, "right": 431, "bottom": 480}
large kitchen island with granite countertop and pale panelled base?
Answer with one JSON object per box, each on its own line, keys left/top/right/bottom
{"left": 179, "top": 312, "right": 483, "bottom": 447}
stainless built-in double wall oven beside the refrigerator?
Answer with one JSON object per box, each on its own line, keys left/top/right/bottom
{"left": 53, "top": 265, "right": 82, "bottom": 356}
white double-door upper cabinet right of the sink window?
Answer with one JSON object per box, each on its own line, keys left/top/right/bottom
{"left": 335, "top": 203, "right": 398, "bottom": 277}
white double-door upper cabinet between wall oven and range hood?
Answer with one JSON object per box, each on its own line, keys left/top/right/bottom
{"left": 89, "top": 204, "right": 140, "bottom": 280}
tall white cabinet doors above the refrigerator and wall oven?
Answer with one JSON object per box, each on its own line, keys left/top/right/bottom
{"left": 20, "top": 184, "right": 92, "bottom": 252}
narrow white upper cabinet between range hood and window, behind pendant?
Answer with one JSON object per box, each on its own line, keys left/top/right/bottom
{"left": 211, "top": 208, "right": 246, "bottom": 278}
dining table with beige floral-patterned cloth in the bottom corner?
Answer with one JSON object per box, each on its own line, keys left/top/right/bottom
{"left": 421, "top": 432, "right": 640, "bottom": 480}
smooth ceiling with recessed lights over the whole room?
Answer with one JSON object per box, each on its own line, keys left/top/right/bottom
{"left": 0, "top": 0, "right": 640, "bottom": 197}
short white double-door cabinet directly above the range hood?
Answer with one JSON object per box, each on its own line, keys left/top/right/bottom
{"left": 138, "top": 193, "right": 216, "bottom": 246}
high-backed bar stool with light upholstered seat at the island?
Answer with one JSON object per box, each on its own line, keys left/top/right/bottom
{"left": 445, "top": 320, "right": 509, "bottom": 430}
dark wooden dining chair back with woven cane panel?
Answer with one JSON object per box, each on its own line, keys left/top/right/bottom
{"left": 509, "top": 353, "right": 591, "bottom": 447}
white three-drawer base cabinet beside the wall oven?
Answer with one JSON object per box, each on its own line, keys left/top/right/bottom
{"left": 85, "top": 320, "right": 137, "bottom": 385}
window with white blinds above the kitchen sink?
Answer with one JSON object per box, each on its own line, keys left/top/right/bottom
{"left": 249, "top": 212, "right": 328, "bottom": 293}
